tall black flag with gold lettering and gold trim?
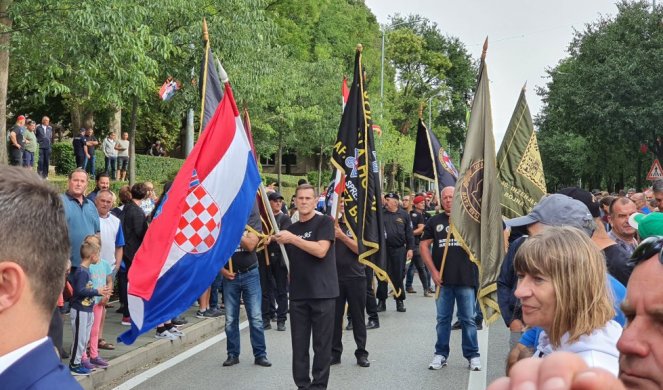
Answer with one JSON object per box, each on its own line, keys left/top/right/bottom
{"left": 332, "top": 45, "right": 388, "bottom": 280}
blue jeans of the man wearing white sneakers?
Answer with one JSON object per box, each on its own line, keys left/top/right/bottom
{"left": 435, "top": 286, "right": 479, "bottom": 360}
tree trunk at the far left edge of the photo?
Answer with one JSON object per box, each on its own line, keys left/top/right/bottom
{"left": 0, "top": 0, "right": 13, "bottom": 164}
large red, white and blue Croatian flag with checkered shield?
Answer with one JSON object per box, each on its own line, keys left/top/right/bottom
{"left": 118, "top": 84, "right": 260, "bottom": 344}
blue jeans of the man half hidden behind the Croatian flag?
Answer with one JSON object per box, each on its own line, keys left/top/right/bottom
{"left": 223, "top": 267, "right": 267, "bottom": 358}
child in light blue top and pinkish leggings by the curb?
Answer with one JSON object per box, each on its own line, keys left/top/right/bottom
{"left": 81, "top": 240, "right": 114, "bottom": 370}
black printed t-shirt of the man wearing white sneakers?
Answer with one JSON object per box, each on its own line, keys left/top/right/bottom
{"left": 421, "top": 213, "right": 479, "bottom": 287}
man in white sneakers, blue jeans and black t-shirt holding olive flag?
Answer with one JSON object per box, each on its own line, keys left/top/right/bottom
{"left": 419, "top": 187, "right": 481, "bottom": 371}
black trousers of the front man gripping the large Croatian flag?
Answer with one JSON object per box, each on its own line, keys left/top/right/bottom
{"left": 290, "top": 298, "right": 336, "bottom": 390}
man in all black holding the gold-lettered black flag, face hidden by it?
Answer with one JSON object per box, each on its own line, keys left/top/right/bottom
{"left": 331, "top": 203, "right": 371, "bottom": 367}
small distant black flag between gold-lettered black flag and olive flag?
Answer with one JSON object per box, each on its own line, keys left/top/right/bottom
{"left": 412, "top": 118, "right": 458, "bottom": 190}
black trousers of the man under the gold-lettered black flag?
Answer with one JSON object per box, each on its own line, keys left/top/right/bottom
{"left": 332, "top": 278, "right": 368, "bottom": 358}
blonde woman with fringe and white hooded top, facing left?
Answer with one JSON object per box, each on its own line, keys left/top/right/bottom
{"left": 514, "top": 227, "right": 622, "bottom": 375}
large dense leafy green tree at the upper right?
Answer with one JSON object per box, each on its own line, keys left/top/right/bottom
{"left": 537, "top": 1, "right": 663, "bottom": 190}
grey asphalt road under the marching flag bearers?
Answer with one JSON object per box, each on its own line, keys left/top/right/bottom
{"left": 119, "top": 278, "right": 508, "bottom": 390}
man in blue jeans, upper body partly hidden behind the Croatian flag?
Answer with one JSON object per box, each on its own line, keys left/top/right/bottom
{"left": 221, "top": 205, "right": 272, "bottom": 367}
